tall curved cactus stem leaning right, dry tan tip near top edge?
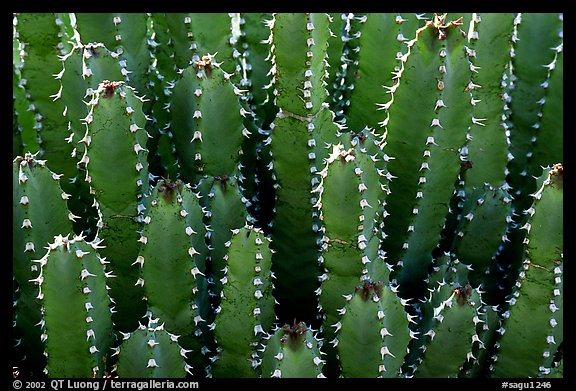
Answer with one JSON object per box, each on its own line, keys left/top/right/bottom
{"left": 382, "top": 15, "right": 470, "bottom": 297}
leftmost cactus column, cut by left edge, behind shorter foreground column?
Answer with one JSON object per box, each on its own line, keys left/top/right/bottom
{"left": 12, "top": 153, "right": 76, "bottom": 373}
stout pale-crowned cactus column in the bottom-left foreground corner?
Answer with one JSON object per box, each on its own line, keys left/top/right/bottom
{"left": 34, "top": 235, "right": 114, "bottom": 377}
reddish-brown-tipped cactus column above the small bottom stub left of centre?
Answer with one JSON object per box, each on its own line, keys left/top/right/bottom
{"left": 134, "top": 179, "right": 209, "bottom": 370}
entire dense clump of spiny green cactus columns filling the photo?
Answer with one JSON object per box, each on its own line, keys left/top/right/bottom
{"left": 12, "top": 12, "right": 564, "bottom": 381}
